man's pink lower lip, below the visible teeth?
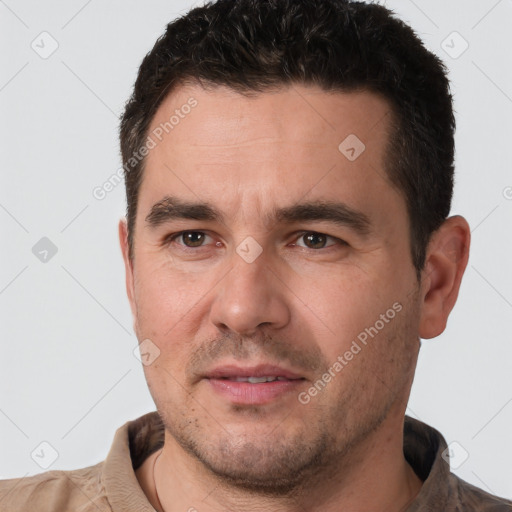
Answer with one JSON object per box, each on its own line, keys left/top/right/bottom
{"left": 207, "top": 379, "right": 304, "bottom": 405}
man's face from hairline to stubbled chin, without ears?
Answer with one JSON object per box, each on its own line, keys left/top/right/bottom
{"left": 122, "top": 86, "right": 419, "bottom": 489}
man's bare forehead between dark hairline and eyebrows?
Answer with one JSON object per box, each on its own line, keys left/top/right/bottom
{"left": 141, "top": 85, "right": 403, "bottom": 226}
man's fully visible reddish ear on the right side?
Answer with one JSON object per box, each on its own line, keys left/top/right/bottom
{"left": 419, "top": 215, "right": 471, "bottom": 339}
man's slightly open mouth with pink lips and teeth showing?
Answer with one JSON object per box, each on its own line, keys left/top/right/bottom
{"left": 204, "top": 365, "right": 306, "bottom": 406}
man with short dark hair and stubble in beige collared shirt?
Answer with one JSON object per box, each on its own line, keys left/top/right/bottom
{"left": 0, "top": 0, "right": 512, "bottom": 512}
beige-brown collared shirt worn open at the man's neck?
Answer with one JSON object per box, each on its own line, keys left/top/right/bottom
{"left": 0, "top": 412, "right": 512, "bottom": 512}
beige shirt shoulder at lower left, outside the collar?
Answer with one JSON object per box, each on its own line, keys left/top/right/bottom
{"left": 0, "top": 462, "right": 111, "bottom": 512}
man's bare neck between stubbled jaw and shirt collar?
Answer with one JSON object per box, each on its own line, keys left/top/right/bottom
{"left": 137, "top": 411, "right": 422, "bottom": 512}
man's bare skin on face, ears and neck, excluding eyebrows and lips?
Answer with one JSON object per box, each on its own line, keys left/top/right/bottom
{"left": 119, "top": 85, "right": 469, "bottom": 512}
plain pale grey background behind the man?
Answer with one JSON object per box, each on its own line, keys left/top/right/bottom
{"left": 0, "top": 0, "right": 512, "bottom": 498}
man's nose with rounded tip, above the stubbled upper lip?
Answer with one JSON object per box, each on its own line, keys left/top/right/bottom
{"left": 210, "top": 254, "right": 290, "bottom": 336}
